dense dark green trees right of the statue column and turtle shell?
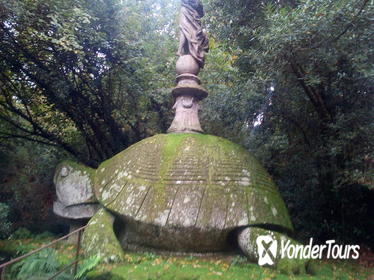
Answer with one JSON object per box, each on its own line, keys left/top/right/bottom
{"left": 207, "top": 0, "right": 374, "bottom": 245}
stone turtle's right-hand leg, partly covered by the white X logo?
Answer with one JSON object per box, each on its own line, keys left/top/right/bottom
{"left": 238, "top": 227, "right": 309, "bottom": 274}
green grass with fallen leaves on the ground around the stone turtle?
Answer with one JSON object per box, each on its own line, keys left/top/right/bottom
{"left": 0, "top": 239, "right": 374, "bottom": 280}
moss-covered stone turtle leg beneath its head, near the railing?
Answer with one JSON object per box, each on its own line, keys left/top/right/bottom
{"left": 82, "top": 208, "right": 123, "bottom": 263}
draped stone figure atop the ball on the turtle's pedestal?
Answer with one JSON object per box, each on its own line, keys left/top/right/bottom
{"left": 178, "top": 0, "right": 209, "bottom": 68}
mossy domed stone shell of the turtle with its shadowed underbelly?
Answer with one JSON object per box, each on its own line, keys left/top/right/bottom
{"left": 94, "top": 134, "right": 292, "bottom": 251}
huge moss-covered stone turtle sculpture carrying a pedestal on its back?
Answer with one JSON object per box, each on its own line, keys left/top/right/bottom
{"left": 55, "top": 134, "right": 305, "bottom": 272}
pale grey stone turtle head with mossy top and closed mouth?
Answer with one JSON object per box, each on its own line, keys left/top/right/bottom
{"left": 53, "top": 161, "right": 97, "bottom": 219}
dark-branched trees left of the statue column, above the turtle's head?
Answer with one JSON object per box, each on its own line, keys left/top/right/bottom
{"left": 0, "top": 0, "right": 178, "bottom": 165}
